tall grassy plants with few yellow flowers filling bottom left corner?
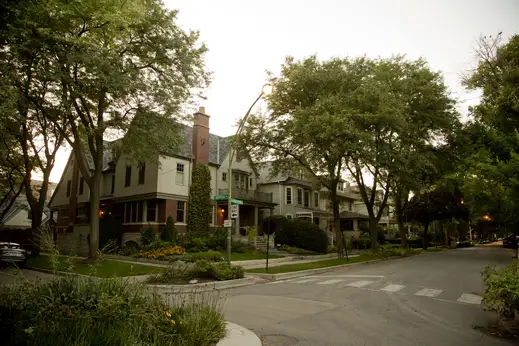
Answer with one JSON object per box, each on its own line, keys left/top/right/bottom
{"left": 0, "top": 276, "right": 225, "bottom": 346}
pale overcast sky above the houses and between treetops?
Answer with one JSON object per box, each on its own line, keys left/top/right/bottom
{"left": 46, "top": 0, "right": 519, "bottom": 181}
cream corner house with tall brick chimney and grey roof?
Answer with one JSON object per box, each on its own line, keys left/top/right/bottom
{"left": 50, "top": 107, "right": 275, "bottom": 252}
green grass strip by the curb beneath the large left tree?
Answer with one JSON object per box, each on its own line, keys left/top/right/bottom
{"left": 27, "top": 255, "right": 163, "bottom": 278}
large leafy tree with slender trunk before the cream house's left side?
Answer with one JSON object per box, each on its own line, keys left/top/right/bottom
{"left": 2, "top": 0, "right": 209, "bottom": 257}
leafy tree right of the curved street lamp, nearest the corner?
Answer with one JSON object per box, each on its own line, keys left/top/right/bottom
{"left": 240, "top": 56, "right": 372, "bottom": 257}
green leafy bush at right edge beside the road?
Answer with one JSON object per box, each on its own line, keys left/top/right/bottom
{"left": 482, "top": 261, "right": 519, "bottom": 319}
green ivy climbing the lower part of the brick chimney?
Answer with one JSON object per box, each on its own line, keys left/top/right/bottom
{"left": 187, "top": 163, "right": 212, "bottom": 235}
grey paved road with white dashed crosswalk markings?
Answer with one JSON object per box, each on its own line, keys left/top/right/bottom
{"left": 225, "top": 248, "right": 512, "bottom": 346}
